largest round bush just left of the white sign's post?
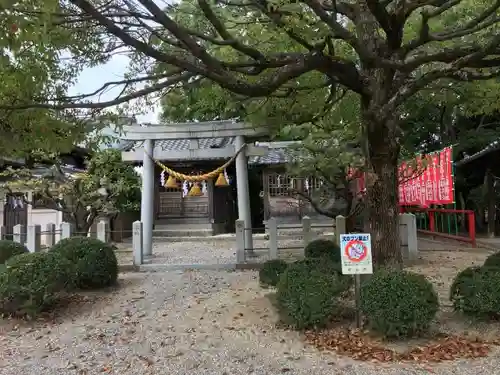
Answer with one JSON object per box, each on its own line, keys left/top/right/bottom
{"left": 276, "top": 259, "right": 350, "bottom": 329}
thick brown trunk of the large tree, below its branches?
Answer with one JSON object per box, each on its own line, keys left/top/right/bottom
{"left": 362, "top": 107, "right": 402, "bottom": 268}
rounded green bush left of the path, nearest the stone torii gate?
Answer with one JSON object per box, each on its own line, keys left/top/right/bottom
{"left": 51, "top": 237, "right": 118, "bottom": 289}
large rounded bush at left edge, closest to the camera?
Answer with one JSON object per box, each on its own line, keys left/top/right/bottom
{"left": 0, "top": 253, "right": 71, "bottom": 316}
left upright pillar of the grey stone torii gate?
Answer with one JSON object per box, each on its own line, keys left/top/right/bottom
{"left": 141, "top": 139, "right": 155, "bottom": 256}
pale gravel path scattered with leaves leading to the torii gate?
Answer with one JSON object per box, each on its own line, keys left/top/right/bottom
{"left": 0, "top": 271, "right": 500, "bottom": 375}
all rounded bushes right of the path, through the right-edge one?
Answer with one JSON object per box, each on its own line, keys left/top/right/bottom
{"left": 266, "top": 240, "right": 500, "bottom": 337}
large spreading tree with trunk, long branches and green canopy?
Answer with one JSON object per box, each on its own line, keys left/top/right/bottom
{"left": 2, "top": 0, "right": 500, "bottom": 264}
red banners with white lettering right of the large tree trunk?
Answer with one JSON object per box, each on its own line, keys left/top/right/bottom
{"left": 398, "top": 147, "right": 454, "bottom": 207}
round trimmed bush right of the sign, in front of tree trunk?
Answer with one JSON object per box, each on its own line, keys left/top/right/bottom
{"left": 361, "top": 270, "right": 439, "bottom": 337}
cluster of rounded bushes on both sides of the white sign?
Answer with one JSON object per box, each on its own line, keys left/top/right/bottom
{"left": 260, "top": 239, "right": 439, "bottom": 336}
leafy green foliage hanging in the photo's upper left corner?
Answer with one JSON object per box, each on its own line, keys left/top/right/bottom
{"left": 0, "top": 0, "right": 107, "bottom": 157}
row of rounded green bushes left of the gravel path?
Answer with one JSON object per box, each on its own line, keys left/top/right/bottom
{"left": 0, "top": 237, "right": 118, "bottom": 316}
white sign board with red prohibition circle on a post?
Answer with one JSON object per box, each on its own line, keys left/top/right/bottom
{"left": 340, "top": 233, "right": 373, "bottom": 275}
